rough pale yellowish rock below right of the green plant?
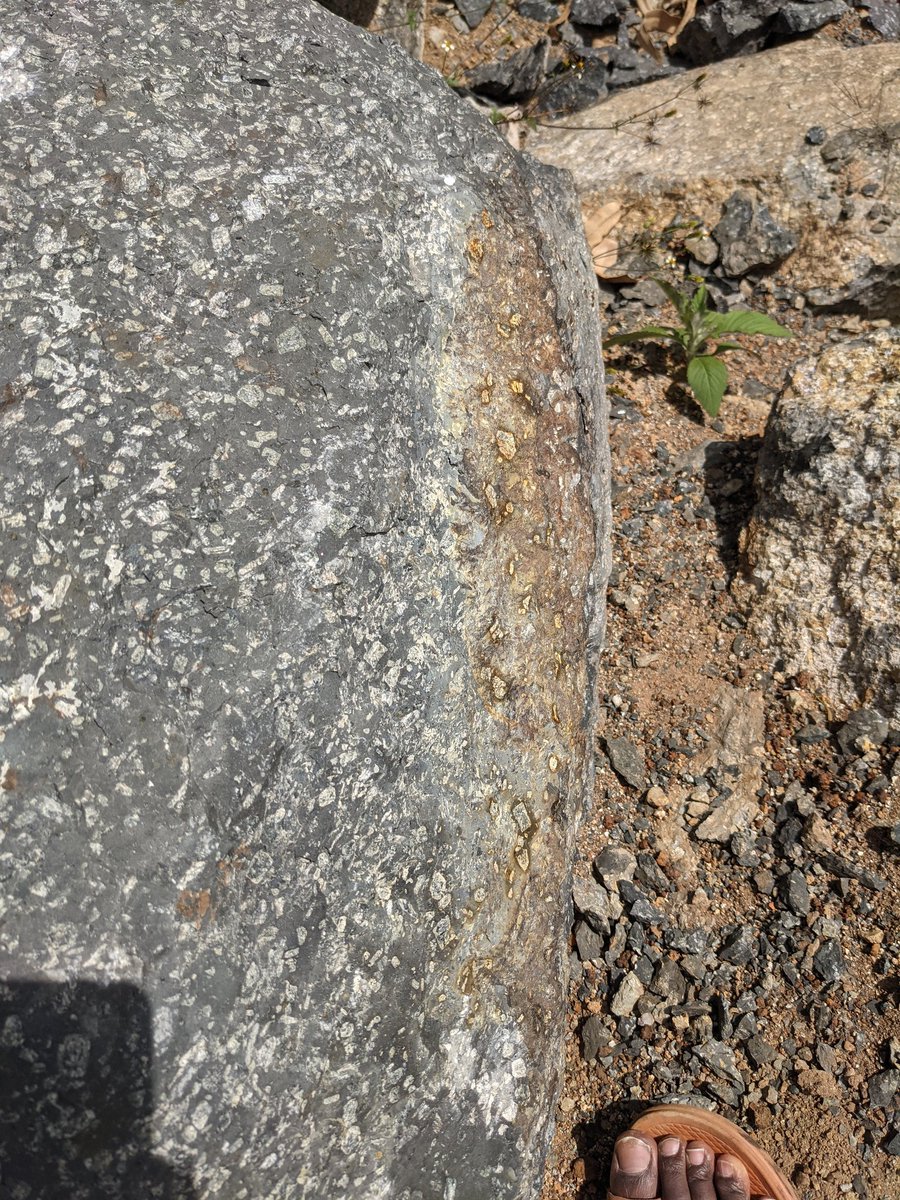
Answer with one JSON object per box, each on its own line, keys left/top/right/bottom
{"left": 737, "top": 330, "right": 900, "bottom": 720}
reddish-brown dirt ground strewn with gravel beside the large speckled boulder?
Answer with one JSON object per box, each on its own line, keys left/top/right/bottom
{"left": 542, "top": 312, "right": 900, "bottom": 1200}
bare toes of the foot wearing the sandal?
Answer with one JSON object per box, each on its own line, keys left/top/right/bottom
{"left": 608, "top": 1129, "right": 773, "bottom": 1200}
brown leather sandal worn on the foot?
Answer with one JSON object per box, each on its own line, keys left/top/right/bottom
{"left": 606, "top": 1104, "right": 799, "bottom": 1200}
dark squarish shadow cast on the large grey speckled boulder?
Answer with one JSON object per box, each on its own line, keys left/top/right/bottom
{"left": 0, "top": 980, "right": 196, "bottom": 1200}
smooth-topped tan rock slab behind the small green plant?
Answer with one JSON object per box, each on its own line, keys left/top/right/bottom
{"left": 527, "top": 40, "right": 900, "bottom": 319}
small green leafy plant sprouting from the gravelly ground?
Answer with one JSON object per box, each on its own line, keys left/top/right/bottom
{"left": 605, "top": 278, "right": 793, "bottom": 416}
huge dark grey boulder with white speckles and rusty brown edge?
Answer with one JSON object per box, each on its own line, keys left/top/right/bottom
{"left": 0, "top": 0, "right": 608, "bottom": 1200}
